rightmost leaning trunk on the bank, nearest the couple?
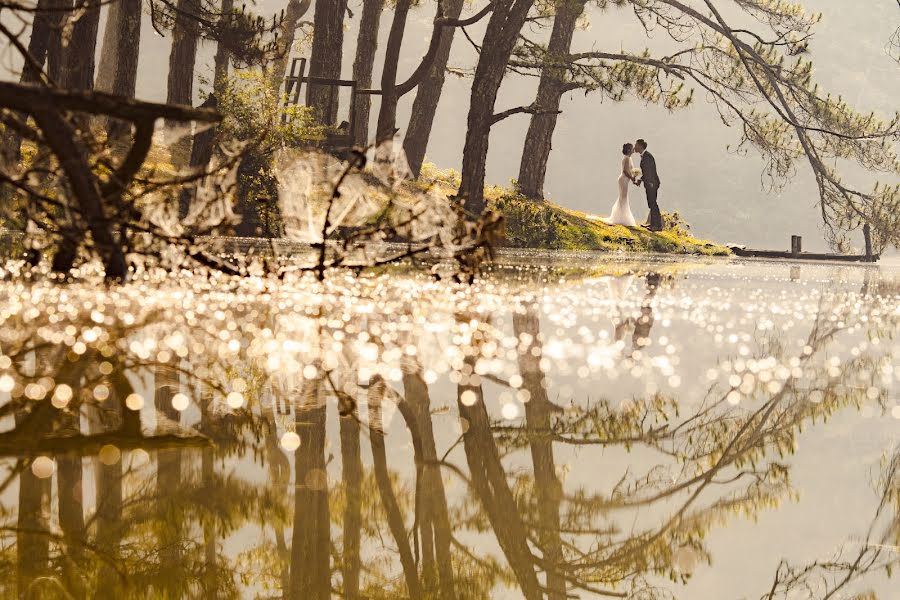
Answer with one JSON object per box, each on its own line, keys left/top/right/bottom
{"left": 518, "top": 0, "right": 586, "bottom": 200}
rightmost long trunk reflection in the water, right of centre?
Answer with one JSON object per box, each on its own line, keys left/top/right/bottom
{"left": 513, "top": 307, "right": 566, "bottom": 600}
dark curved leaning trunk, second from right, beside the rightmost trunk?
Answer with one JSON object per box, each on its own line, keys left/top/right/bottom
{"left": 458, "top": 0, "right": 534, "bottom": 215}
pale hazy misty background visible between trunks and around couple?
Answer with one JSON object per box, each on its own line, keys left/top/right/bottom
{"left": 0, "top": 0, "right": 900, "bottom": 250}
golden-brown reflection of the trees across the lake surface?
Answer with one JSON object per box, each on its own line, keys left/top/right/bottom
{"left": 0, "top": 273, "right": 900, "bottom": 600}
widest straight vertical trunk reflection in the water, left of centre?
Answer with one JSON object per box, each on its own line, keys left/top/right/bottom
{"left": 287, "top": 381, "right": 331, "bottom": 600}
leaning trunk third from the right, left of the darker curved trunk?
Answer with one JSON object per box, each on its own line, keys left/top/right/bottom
{"left": 403, "top": 0, "right": 465, "bottom": 178}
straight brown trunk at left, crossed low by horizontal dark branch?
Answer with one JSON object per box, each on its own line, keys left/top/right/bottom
{"left": 166, "top": 0, "right": 200, "bottom": 166}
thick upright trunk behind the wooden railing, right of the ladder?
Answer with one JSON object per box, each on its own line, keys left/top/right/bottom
{"left": 306, "top": 0, "right": 352, "bottom": 125}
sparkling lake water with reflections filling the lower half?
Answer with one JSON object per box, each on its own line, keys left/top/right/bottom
{"left": 0, "top": 253, "right": 900, "bottom": 600}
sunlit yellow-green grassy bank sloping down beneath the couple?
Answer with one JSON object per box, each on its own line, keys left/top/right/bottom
{"left": 421, "top": 165, "right": 731, "bottom": 256}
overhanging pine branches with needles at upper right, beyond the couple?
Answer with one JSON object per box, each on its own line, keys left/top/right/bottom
{"left": 510, "top": 0, "right": 900, "bottom": 253}
